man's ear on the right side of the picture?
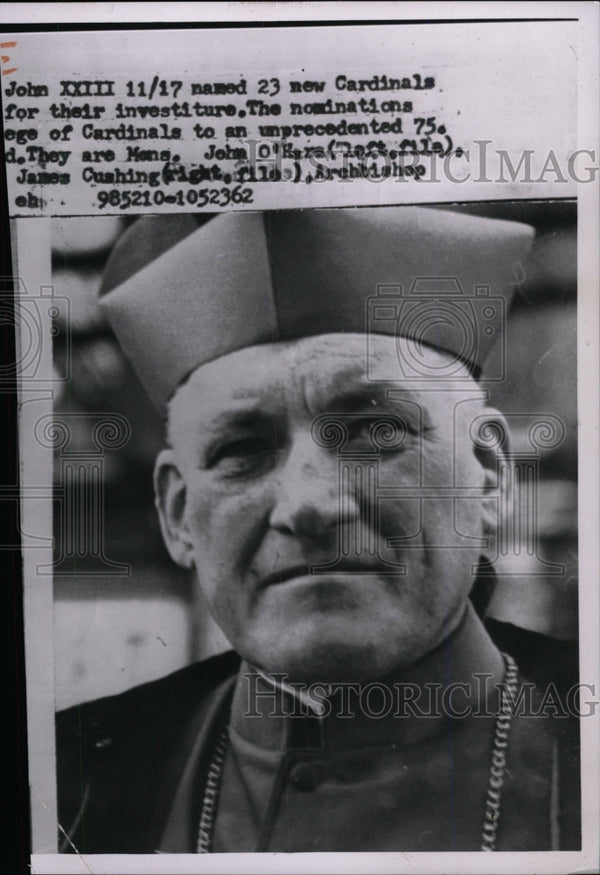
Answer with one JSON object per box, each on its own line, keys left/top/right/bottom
{"left": 474, "top": 407, "right": 512, "bottom": 558}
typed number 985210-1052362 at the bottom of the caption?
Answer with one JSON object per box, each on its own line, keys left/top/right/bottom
{"left": 97, "top": 185, "right": 254, "bottom": 210}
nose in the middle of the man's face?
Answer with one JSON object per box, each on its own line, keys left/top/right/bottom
{"left": 270, "top": 434, "right": 359, "bottom": 538}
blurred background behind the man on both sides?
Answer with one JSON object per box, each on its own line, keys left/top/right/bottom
{"left": 52, "top": 201, "right": 578, "bottom": 708}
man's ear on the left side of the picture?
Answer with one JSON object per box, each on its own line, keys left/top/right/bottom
{"left": 154, "top": 449, "right": 193, "bottom": 568}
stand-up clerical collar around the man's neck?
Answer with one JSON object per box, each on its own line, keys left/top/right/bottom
{"left": 230, "top": 604, "right": 504, "bottom": 750}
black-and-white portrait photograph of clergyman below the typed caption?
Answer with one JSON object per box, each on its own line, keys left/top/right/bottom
{"left": 53, "top": 203, "right": 580, "bottom": 853}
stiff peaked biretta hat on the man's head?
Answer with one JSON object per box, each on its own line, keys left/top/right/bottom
{"left": 101, "top": 206, "right": 533, "bottom": 409}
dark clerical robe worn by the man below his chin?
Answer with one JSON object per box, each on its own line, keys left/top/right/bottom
{"left": 58, "top": 608, "right": 580, "bottom": 853}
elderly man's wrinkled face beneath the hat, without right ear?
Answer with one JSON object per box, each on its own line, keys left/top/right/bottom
{"left": 156, "top": 335, "right": 491, "bottom": 682}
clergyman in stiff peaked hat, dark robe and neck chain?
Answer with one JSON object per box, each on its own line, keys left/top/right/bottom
{"left": 58, "top": 207, "right": 579, "bottom": 853}
